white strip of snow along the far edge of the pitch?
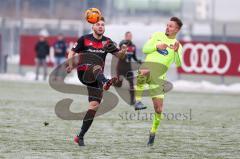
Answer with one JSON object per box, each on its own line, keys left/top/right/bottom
{"left": 0, "top": 72, "right": 240, "bottom": 94}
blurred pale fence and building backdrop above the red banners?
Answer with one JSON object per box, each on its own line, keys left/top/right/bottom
{"left": 0, "top": 0, "right": 240, "bottom": 84}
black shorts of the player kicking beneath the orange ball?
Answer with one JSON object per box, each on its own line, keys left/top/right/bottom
{"left": 78, "top": 71, "right": 103, "bottom": 103}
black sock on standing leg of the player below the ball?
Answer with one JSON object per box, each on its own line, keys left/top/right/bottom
{"left": 78, "top": 109, "right": 96, "bottom": 138}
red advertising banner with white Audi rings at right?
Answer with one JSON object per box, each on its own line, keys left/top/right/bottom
{"left": 178, "top": 41, "right": 240, "bottom": 76}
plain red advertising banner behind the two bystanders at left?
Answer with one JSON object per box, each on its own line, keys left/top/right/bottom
{"left": 20, "top": 35, "right": 77, "bottom": 66}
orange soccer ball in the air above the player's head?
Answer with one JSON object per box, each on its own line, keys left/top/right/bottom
{"left": 85, "top": 8, "right": 102, "bottom": 24}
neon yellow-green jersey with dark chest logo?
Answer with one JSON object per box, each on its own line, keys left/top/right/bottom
{"left": 143, "top": 32, "right": 182, "bottom": 68}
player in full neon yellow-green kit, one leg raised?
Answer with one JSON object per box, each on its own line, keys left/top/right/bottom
{"left": 135, "top": 17, "right": 183, "bottom": 146}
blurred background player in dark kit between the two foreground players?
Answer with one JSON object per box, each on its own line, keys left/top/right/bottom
{"left": 114, "top": 31, "right": 141, "bottom": 105}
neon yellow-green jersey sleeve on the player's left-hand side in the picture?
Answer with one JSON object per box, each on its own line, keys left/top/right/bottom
{"left": 142, "top": 33, "right": 158, "bottom": 54}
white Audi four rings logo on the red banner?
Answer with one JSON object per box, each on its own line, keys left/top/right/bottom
{"left": 182, "top": 43, "right": 231, "bottom": 74}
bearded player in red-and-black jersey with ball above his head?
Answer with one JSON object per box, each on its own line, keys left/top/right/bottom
{"left": 64, "top": 17, "right": 127, "bottom": 146}
